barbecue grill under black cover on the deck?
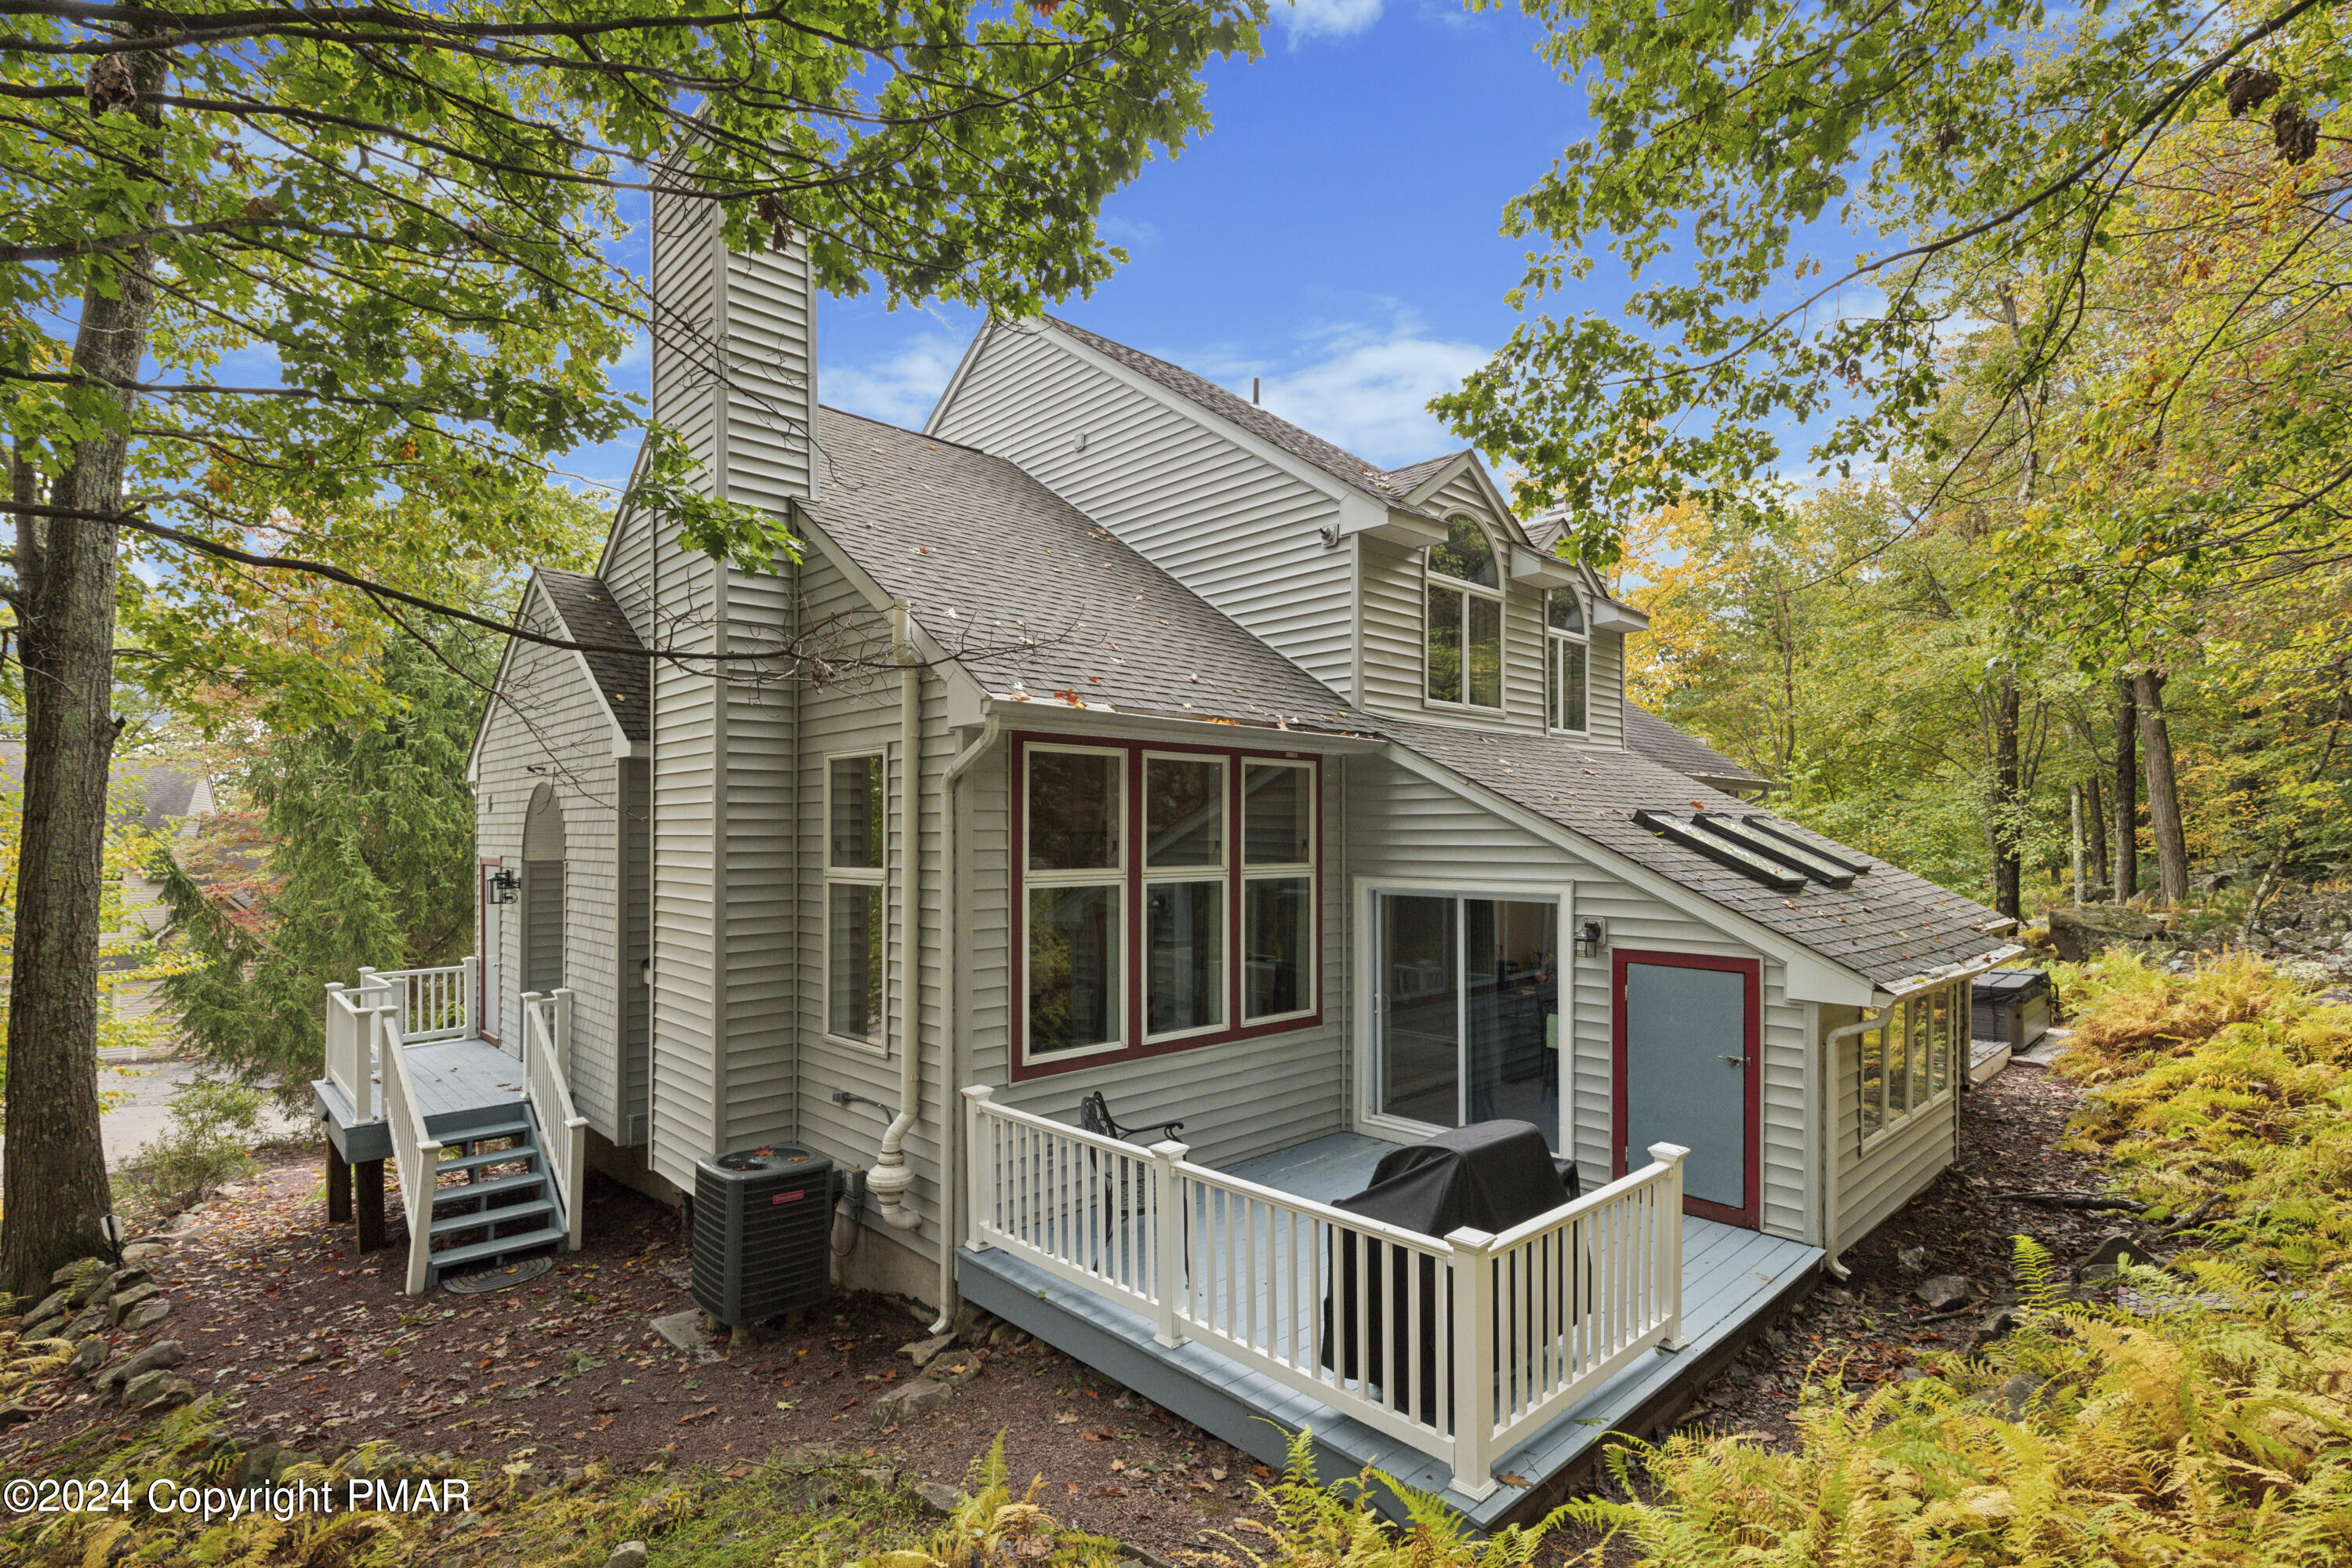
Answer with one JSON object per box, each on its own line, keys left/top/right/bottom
{"left": 1322, "top": 1121, "right": 1590, "bottom": 1425}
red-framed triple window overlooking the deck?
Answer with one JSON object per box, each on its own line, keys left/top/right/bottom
{"left": 1011, "top": 734, "right": 1322, "bottom": 1079}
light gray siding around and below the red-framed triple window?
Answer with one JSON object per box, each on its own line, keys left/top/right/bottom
{"left": 960, "top": 755, "right": 1352, "bottom": 1166}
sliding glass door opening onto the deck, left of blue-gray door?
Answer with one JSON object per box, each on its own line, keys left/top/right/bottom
{"left": 1371, "top": 893, "right": 1562, "bottom": 1152}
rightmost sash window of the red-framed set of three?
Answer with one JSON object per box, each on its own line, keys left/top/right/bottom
{"left": 1242, "top": 757, "right": 1317, "bottom": 1025}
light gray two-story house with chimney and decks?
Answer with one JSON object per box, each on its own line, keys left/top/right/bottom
{"left": 320, "top": 202, "right": 2011, "bottom": 1523}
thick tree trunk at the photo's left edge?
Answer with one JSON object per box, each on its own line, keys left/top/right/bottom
{"left": 0, "top": 52, "right": 162, "bottom": 1295}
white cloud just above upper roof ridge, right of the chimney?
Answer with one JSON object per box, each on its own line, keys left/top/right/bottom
{"left": 1251, "top": 310, "right": 1489, "bottom": 468}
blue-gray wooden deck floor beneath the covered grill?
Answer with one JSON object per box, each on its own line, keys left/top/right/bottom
{"left": 957, "top": 1133, "right": 1823, "bottom": 1530}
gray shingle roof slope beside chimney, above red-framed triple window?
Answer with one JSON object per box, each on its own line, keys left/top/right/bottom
{"left": 804, "top": 409, "right": 1362, "bottom": 731}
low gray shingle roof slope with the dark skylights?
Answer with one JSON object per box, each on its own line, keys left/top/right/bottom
{"left": 1381, "top": 720, "right": 2009, "bottom": 985}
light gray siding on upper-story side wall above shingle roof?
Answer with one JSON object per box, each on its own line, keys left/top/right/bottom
{"left": 936, "top": 327, "right": 1352, "bottom": 694}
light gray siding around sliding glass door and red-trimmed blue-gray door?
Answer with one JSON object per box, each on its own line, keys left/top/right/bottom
{"left": 1345, "top": 757, "right": 1806, "bottom": 1239}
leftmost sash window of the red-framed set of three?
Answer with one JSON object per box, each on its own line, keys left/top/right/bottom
{"left": 1021, "top": 746, "right": 1127, "bottom": 1060}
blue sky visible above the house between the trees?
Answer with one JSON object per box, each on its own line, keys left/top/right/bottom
{"left": 572, "top": 0, "right": 1590, "bottom": 482}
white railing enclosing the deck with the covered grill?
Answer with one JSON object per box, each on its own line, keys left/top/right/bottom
{"left": 964, "top": 1086, "right": 1686, "bottom": 1497}
